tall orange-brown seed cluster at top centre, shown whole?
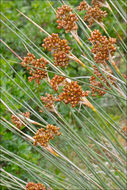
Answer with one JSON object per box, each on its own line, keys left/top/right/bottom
{"left": 56, "top": 5, "right": 78, "bottom": 33}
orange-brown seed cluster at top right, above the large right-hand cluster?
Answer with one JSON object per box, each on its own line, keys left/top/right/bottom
{"left": 84, "top": 6, "right": 107, "bottom": 27}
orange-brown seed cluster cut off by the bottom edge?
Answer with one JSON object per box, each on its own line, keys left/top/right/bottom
{"left": 26, "top": 182, "right": 46, "bottom": 190}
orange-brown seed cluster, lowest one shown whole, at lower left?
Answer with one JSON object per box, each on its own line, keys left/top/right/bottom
{"left": 33, "top": 124, "right": 61, "bottom": 147}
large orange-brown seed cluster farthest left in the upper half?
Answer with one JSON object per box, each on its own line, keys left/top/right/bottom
{"left": 21, "top": 53, "right": 48, "bottom": 84}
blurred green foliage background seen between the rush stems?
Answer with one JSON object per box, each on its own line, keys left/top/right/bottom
{"left": 1, "top": 0, "right": 126, "bottom": 190}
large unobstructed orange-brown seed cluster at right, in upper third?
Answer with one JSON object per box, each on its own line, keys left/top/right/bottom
{"left": 89, "top": 30, "right": 116, "bottom": 64}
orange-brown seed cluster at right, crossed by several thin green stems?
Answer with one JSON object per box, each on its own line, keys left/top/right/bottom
{"left": 89, "top": 65, "right": 115, "bottom": 96}
